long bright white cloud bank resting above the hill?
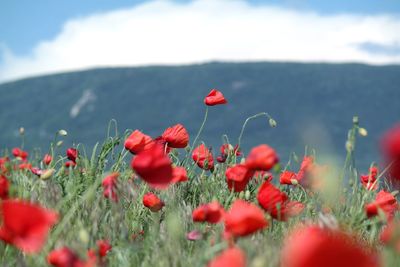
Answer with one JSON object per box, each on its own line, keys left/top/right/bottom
{"left": 0, "top": 0, "right": 400, "bottom": 81}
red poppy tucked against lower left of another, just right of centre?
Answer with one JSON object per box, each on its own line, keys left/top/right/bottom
{"left": 225, "top": 164, "right": 254, "bottom": 192}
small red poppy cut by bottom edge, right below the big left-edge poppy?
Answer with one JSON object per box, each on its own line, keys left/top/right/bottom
{"left": 47, "top": 247, "right": 88, "bottom": 267}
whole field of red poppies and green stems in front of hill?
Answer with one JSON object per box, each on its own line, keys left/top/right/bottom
{"left": 0, "top": 89, "right": 400, "bottom": 267}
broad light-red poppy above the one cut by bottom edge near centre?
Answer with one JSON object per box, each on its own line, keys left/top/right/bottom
{"left": 224, "top": 199, "right": 268, "bottom": 236}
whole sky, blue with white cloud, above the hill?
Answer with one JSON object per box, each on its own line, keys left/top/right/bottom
{"left": 0, "top": 0, "right": 400, "bottom": 82}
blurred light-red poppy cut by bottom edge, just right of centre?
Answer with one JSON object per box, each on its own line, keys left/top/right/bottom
{"left": 207, "top": 247, "right": 246, "bottom": 267}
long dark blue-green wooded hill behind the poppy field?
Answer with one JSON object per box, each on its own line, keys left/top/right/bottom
{"left": 0, "top": 63, "right": 400, "bottom": 169}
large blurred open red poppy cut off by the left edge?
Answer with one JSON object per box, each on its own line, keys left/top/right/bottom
{"left": 0, "top": 199, "right": 58, "bottom": 253}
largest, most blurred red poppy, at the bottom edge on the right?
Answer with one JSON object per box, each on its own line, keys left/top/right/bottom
{"left": 281, "top": 226, "right": 380, "bottom": 267}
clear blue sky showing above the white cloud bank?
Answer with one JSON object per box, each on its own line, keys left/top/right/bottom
{"left": 0, "top": 0, "right": 400, "bottom": 54}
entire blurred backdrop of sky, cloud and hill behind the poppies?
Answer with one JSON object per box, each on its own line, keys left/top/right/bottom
{"left": 0, "top": 0, "right": 400, "bottom": 168}
